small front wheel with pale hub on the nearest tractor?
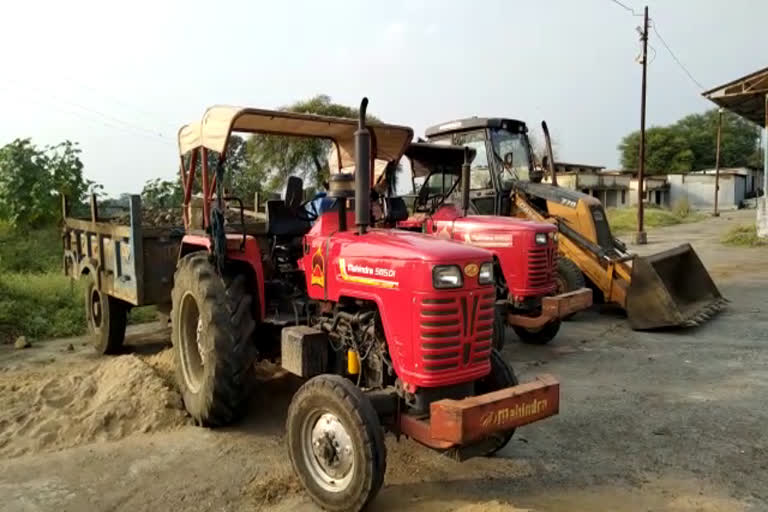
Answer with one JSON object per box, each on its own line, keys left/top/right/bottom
{"left": 286, "top": 375, "right": 387, "bottom": 511}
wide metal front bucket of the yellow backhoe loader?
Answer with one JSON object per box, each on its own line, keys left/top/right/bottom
{"left": 626, "top": 244, "right": 728, "bottom": 330}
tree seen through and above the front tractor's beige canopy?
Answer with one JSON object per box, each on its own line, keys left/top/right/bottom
{"left": 246, "top": 94, "right": 377, "bottom": 194}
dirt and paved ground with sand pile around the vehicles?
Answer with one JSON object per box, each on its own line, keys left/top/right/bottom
{"left": 0, "top": 211, "right": 768, "bottom": 512}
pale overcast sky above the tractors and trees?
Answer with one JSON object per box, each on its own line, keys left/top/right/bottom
{"left": 0, "top": 0, "right": 768, "bottom": 194}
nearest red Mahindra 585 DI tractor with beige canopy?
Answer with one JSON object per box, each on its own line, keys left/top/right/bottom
{"left": 171, "top": 100, "right": 559, "bottom": 510}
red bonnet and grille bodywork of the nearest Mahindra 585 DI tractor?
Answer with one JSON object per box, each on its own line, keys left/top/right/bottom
{"left": 300, "top": 212, "right": 495, "bottom": 389}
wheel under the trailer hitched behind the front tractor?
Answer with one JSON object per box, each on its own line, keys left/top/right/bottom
{"left": 84, "top": 275, "right": 130, "bottom": 355}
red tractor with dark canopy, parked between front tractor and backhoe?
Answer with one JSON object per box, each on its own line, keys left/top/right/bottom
{"left": 390, "top": 143, "right": 592, "bottom": 349}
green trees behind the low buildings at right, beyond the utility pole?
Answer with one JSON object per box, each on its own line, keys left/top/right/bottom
{"left": 619, "top": 109, "right": 762, "bottom": 174}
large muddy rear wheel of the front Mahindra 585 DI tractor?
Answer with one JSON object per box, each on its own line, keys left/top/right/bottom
{"left": 171, "top": 252, "right": 256, "bottom": 427}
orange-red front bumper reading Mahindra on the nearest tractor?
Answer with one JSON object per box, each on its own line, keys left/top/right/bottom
{"left": 399, "top": 374, "right": 560, "bottom": 450}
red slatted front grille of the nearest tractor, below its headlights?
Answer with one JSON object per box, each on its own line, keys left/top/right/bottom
{"left": 418, "top": 290, "right": 495, "bottom": 373}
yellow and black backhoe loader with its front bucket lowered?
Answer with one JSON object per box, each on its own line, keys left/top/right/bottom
{"left": 426, "top": 117, "right": 727, "bottom": 330}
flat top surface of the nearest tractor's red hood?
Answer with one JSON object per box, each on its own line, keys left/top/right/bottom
{"left": 334, "top": 229, "right": 492, "bottom": 262}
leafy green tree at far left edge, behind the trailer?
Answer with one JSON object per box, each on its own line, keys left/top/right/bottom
{"left": 0, "top": 139, "right": 93, "bottom": 228}
